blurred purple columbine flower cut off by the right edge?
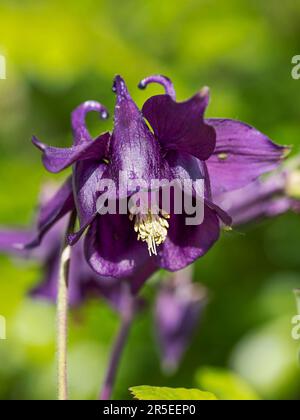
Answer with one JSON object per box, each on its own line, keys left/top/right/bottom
{"left": 216, "top": 159, "right": 300, "bottom": 226}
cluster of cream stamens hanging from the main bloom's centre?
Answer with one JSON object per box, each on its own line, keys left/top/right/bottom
{"left": 130, "top": 211, "right": 170, "bottom": 256}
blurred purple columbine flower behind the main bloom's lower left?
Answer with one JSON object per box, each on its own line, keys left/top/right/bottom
{"left": 0, "top": 188, "right": 153, "bottom": 313}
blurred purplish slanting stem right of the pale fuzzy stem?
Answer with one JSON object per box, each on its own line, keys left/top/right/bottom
{"left": 99, "top": 304, "right": 134, "bottom": 400}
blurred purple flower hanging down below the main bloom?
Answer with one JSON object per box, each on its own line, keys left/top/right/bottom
{"left": 155, "top": 268, "right": 206, "bottom": 372}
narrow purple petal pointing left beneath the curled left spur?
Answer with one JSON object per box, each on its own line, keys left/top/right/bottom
{"left": 32, "top": 133, "right": 110, "bottom": 173}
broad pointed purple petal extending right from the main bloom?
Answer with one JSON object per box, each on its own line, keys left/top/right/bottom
{"left": 206, "top": 119, "right": 287, "bottom": 196}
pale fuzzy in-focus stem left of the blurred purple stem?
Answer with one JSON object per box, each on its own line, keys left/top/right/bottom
{"left": 57, "top": 212, "right": 76, "bottom": 401}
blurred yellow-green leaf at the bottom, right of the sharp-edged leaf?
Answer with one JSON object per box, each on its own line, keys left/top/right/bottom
{"left": 196, "top": 367, "right": 260, "bottom": 400}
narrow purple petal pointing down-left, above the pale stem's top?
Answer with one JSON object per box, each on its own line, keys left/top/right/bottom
{"left": 26, "top": 177, "right": 75, "bottom": 248}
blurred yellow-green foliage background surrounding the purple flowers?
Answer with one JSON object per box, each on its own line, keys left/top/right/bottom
{"left": 0, "top": 0, "right": 300, "bottom": 399}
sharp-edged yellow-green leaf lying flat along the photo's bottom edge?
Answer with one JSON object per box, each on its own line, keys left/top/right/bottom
{"left": 129, "top": 385, "right": 217, "bottom": 401}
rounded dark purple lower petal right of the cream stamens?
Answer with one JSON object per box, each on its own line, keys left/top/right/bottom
{"left": 158, "top": 205, "right": 220, "bottom": 271}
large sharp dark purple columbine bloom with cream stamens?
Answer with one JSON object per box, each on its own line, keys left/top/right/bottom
{"left": 29, "top": 76, "right": 286, "bottom": 277}
